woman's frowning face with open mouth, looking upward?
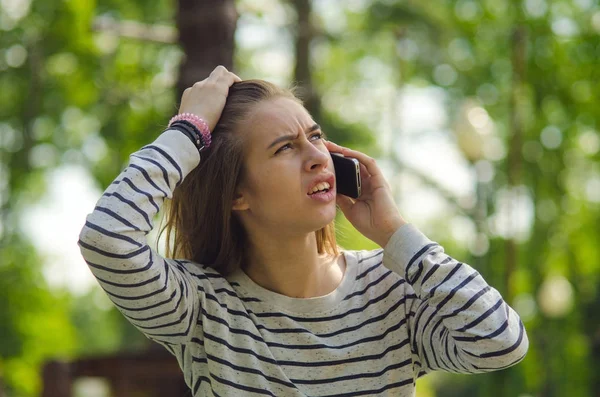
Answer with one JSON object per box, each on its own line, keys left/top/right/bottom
{"left": 234, "top": 97, "right": 336, "bottom": 234}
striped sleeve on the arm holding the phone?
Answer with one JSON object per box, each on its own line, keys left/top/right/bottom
{"left": 383, "top": 224, "right": 529, "bottom": 376}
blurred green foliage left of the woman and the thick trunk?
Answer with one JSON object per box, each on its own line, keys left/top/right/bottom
{"left": 0, "top": 0, "right": 175, "bottom": 396}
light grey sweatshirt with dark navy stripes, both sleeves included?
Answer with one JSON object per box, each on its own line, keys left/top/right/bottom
{"left": 79, "top": 130, "right": 528, "bottom": 397}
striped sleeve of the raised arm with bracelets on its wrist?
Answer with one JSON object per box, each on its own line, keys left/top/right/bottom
{"left": 78, "top": 130, "right": 210, "bottom": 343}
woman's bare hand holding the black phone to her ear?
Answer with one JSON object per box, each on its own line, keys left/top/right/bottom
{"left": 325, "top": 141, "right": 406, "bottom": 247}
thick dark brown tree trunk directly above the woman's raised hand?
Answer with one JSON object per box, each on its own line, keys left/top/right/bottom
{"left": 177, "top": 0, "right": 238, "bottom": 97}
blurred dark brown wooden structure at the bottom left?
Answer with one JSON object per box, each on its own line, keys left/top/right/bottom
{"left": 42, "top": 348, "right": 186, "bottom": 397}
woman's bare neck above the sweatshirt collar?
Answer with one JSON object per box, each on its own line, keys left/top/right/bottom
{"left": 244, "top": 233, "right": 346, "bottom": 298}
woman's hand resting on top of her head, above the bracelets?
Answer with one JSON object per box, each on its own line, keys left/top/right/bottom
{"left": 179, "top": 65, "right": 242, "bottom": 131}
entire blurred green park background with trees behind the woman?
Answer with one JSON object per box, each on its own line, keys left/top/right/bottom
{"left": 0, "top": 0, "right": 600, "bottom": 397}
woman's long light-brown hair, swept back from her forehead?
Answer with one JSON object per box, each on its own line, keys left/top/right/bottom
{"left": 161, "top": 80, "right": 339, "bottom": 276}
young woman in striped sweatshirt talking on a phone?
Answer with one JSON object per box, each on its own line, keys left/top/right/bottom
{"left": 79, "top": 67, "right": 528, "bottom": 396}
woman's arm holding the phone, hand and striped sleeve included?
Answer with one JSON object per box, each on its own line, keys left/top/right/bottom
{"left": 327, "top": 142, "right": 528, "bottom": 372}
